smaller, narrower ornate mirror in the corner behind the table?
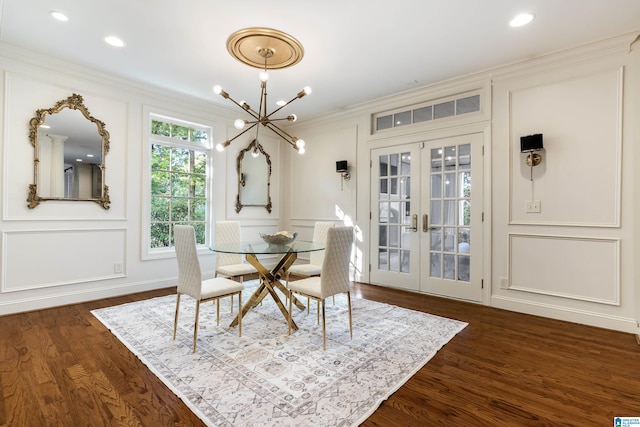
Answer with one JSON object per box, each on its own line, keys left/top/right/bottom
{"left": 236, "top": 139, "right": 271, "bottom": 213}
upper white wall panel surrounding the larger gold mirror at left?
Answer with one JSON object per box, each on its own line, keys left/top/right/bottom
{"left": 0, "top": 73, "right": 129, "bottom": 221}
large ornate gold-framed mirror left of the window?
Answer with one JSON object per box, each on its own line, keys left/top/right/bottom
{"left": 27, "top": 93, "right": 111, "bottom": 209}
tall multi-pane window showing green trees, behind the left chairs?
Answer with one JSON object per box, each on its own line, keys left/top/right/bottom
{"left": 148, "top": 116, "right": 211, "bottom": 251}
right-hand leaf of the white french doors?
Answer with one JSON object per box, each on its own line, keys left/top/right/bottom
{"left": 420, "top": 134, "right": 483, "bottom": 301}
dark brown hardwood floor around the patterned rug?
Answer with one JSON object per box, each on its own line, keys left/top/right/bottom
{"left": 0, "top": 284, "right": 640, "bottom": 427}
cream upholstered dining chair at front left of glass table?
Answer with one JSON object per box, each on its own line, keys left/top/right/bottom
{"left": 173, "top": 225, "right": 242, "bottom": 353}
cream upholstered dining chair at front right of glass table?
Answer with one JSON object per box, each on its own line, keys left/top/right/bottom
{"left": 289, "top": 227, "right": 353, "bottom": 350}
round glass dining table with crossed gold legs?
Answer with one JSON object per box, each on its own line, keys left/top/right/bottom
{"left": 210, "top": 240, "right": 325, "bottom": 330}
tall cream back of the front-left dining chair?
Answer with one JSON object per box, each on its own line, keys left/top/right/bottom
{"left": 173, "top": 225, "right": 202, "bottom": 299}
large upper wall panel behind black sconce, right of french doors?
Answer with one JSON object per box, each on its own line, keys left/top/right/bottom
{"left": 509, "top": 67, "right": 624, "bottom": 227}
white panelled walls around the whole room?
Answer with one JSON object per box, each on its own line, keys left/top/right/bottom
{"left": 0, "top": 30, "right": 640, "bottom": 333}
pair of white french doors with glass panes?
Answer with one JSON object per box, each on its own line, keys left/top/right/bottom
{"left": 370, "top": 134, "right": 483, "bottom": 301}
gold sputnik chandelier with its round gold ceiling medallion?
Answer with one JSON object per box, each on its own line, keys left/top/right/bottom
{"left": 213, "top": 28, "right": 311, "bottom": 154}
